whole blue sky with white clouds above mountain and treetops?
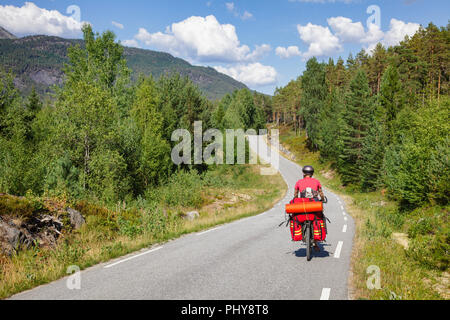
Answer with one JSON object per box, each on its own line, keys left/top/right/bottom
{"left": 0, "top": 0, "right": 450, "bottom": 94}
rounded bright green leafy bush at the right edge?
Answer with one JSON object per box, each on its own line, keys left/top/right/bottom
{"left": 383, "top": 97, "right": 450, "bottom": 207}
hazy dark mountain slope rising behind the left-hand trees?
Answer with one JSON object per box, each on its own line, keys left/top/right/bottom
{"left": 0, "top": 32, "right": 246, "bottom": 100}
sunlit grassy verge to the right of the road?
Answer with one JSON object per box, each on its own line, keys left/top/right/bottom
{"left": 280, "top": 127, "right": 450, "bottom": 300}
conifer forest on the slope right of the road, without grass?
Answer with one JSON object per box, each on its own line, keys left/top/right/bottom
{"left": 273, "top": 24, "right": 450, "bottom": 207}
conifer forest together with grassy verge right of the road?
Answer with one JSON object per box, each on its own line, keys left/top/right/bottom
{"left": 273, "top": 24, "right": 450, "bottom": 299}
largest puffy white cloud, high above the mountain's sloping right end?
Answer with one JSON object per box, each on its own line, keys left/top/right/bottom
{"left": 134, "top": 15, "right": 271, "bottom": 63}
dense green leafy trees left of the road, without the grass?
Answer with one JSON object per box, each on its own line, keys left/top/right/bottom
{"left": 0, "top": 27, "right": 265, "bottom": 203}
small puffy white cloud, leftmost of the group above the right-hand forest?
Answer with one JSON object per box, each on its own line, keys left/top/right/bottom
{"left": 297, "top": 23, "right": 342, "bottom": 59}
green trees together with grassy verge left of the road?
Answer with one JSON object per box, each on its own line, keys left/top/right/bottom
{"left": 0, "top": 26, "right": 286, "bottom": 298}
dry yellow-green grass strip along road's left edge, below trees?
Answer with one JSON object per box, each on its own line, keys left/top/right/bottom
{"left": 0, "top": 165, "right": 286, "bottom": 299}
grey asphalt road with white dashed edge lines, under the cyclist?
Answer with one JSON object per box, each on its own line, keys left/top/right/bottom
{"left": 12, "top": 137, "right": 355, "bottom": 300}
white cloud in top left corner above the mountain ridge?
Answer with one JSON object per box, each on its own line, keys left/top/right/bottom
{"left": 0, "top": 2, "right": 85, "bottom": 37}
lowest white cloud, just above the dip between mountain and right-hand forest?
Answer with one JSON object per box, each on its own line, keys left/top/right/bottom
{"left": 215, "top": 62, "right": 278, "bottom": 87}
